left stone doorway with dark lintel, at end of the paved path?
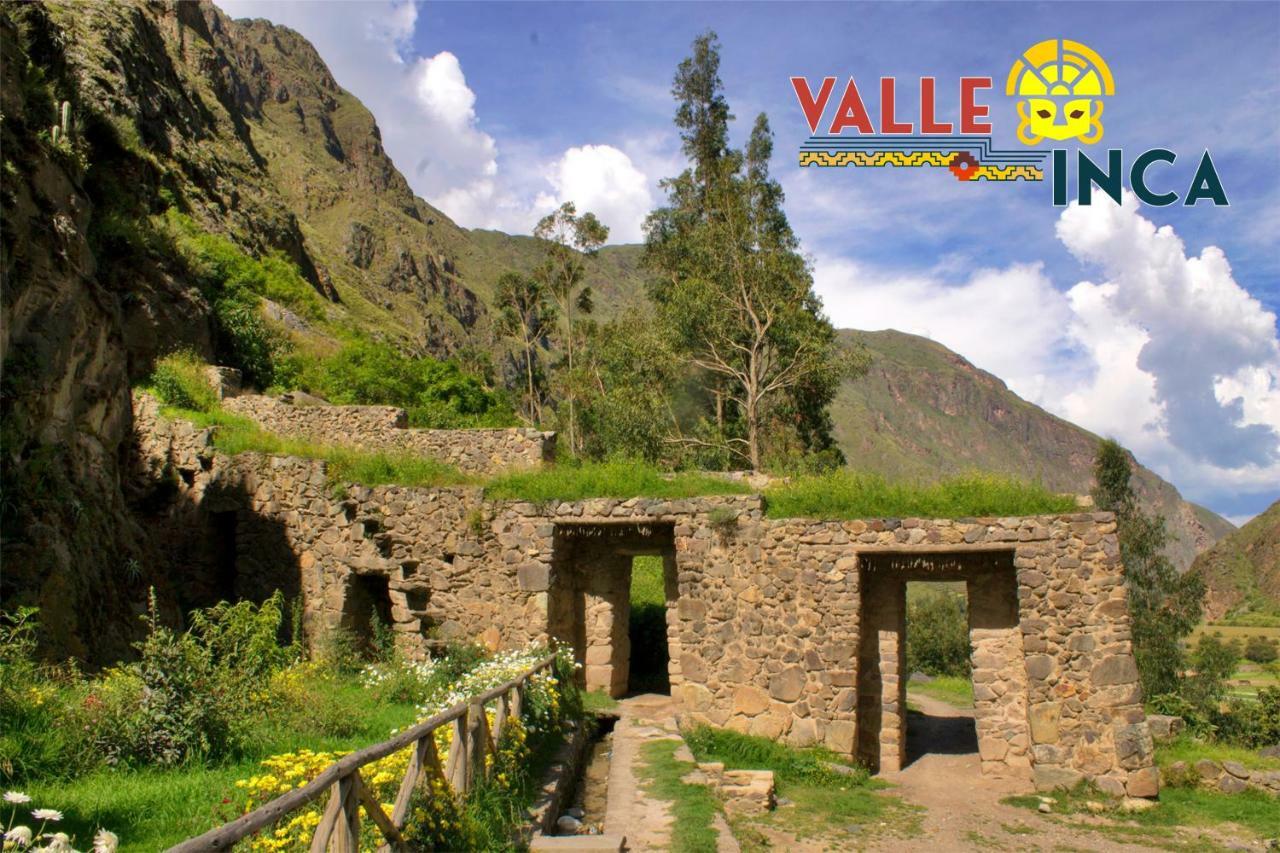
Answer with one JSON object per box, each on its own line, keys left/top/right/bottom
{"left": 548, "top": 521, "right": 680, "bottom": 698}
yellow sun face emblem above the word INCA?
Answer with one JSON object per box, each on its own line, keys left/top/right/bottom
{"left": 1005, "top": 38, "right": 1116, "bottom": 145}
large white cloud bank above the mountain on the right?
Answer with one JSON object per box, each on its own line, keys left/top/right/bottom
{"left": 814, "top": 196, "right": 1280, "bottom": 500}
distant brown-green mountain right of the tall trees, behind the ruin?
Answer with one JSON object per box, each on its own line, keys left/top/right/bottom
{"left": 831, "top": 329, "right": 1234, "bottom": 570}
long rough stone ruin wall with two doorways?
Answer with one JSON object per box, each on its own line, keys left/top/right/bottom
{"left": 134, "top": 394, "right": 1157, "bottom": 797}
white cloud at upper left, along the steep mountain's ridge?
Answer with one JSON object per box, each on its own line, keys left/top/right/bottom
{"left": 218, "top": 0, "right": 653, "bottom": 242}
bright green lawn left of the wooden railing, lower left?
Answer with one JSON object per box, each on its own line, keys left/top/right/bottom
{"left": 18, "top": 681, "right": 417, "bottom": 853}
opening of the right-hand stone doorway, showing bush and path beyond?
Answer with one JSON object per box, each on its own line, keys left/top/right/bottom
{"left": 904, "top": 580, "right": 978, "bottom": 766}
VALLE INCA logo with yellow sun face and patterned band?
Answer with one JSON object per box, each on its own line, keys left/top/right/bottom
{"left": 791, "top": 38, "right": 1229, "bottom": 206}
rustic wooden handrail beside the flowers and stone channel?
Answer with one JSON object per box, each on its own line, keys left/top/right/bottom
{"left": 168, "top": 654, "right": 556, "bottom": 853}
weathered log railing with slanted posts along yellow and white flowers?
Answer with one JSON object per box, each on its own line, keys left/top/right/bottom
{"left": 169, "top": 654, "right": 556, "bottom": 853}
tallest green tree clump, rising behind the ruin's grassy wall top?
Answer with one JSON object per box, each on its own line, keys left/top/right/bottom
{"left": 645, "top": 33, "right": 865, "bottom": 469}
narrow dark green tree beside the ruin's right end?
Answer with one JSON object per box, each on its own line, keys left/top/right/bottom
{"left": 1093, "top": 438, "right": 1204, "bottom": 698}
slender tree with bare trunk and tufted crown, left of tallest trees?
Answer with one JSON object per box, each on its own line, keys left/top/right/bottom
{"left": 534, "top": 201, "right": 609, "bottom": 453}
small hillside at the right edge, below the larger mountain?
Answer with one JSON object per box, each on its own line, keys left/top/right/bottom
{"left": 1192, "top": 501, "right": 1280, "bottom": 620}
